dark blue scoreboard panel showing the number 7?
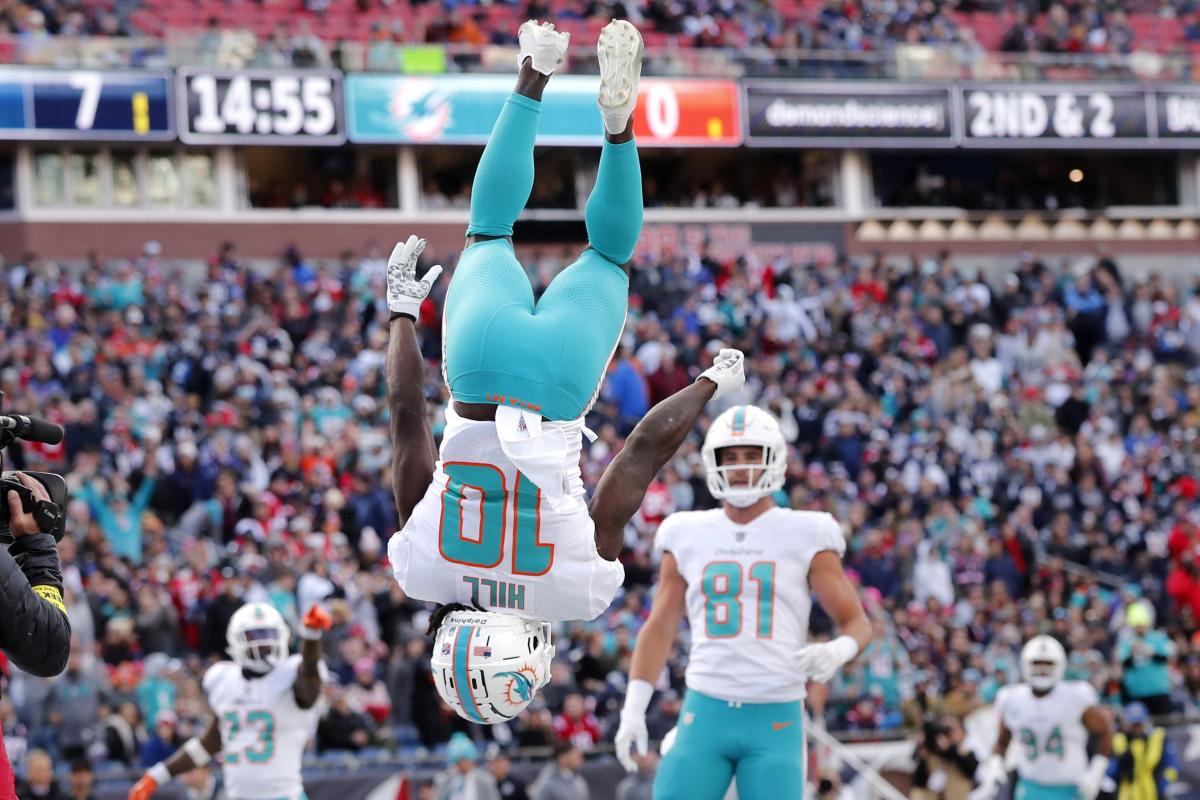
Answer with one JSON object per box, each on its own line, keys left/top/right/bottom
{"left": 0, "top": 68, "right": 176, "bottom": 142}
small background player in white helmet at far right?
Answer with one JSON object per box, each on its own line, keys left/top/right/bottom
{"left": 971, "top": 636, "right": 1112, "bottom": 800}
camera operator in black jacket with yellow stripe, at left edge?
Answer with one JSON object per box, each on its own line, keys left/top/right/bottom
{"left": 0, "top": 473, "right": 71, "bottom": 800}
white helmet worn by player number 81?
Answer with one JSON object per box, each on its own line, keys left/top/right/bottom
{"left": 700, "top": 405, "right": 787, "bottom": 509}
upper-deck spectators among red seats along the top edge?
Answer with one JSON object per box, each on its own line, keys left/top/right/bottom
{"left": 7, "top": 0, "right": 1200, "bottom": 57}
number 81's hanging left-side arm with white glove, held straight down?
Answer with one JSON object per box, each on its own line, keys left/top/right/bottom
{"left": 616, "top": 553, "right": 688, "bottom": 772}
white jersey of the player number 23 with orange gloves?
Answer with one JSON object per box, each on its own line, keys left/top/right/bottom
{"left": 202, "top": 655, "right": 328, "bottom": 800}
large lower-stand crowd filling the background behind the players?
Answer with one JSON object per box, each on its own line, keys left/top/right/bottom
{"left": 0, "top": 242, "right": 1200, "bottom": 782}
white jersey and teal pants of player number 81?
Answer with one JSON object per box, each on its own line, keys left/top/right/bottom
{"left": 654, "top": 509, "right": 845, "bottom": 800}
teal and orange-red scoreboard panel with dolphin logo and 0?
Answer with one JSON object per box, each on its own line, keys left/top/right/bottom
{"left": 346, "top": 74, "right": 742, "bottom": 148}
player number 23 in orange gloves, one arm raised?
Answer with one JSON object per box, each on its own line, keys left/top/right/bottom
{"left": 130, "top": 603, "right": 332, "bottom": 800}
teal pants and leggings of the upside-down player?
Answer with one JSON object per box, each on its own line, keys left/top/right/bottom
{"left": 442, "top": 94, "right": 642, "bottom": 420}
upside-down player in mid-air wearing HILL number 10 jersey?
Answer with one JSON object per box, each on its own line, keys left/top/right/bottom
{"left": 388, "top": 22, "right": 744, "bottom": 723}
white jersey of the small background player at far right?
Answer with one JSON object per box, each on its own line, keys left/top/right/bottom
{"left": 996, "top": 680, "right": 1099, "bottom": 786}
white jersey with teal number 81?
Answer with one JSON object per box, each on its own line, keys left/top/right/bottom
{"left": 654, "top": 509, "right": 846, "bottom": 703}
